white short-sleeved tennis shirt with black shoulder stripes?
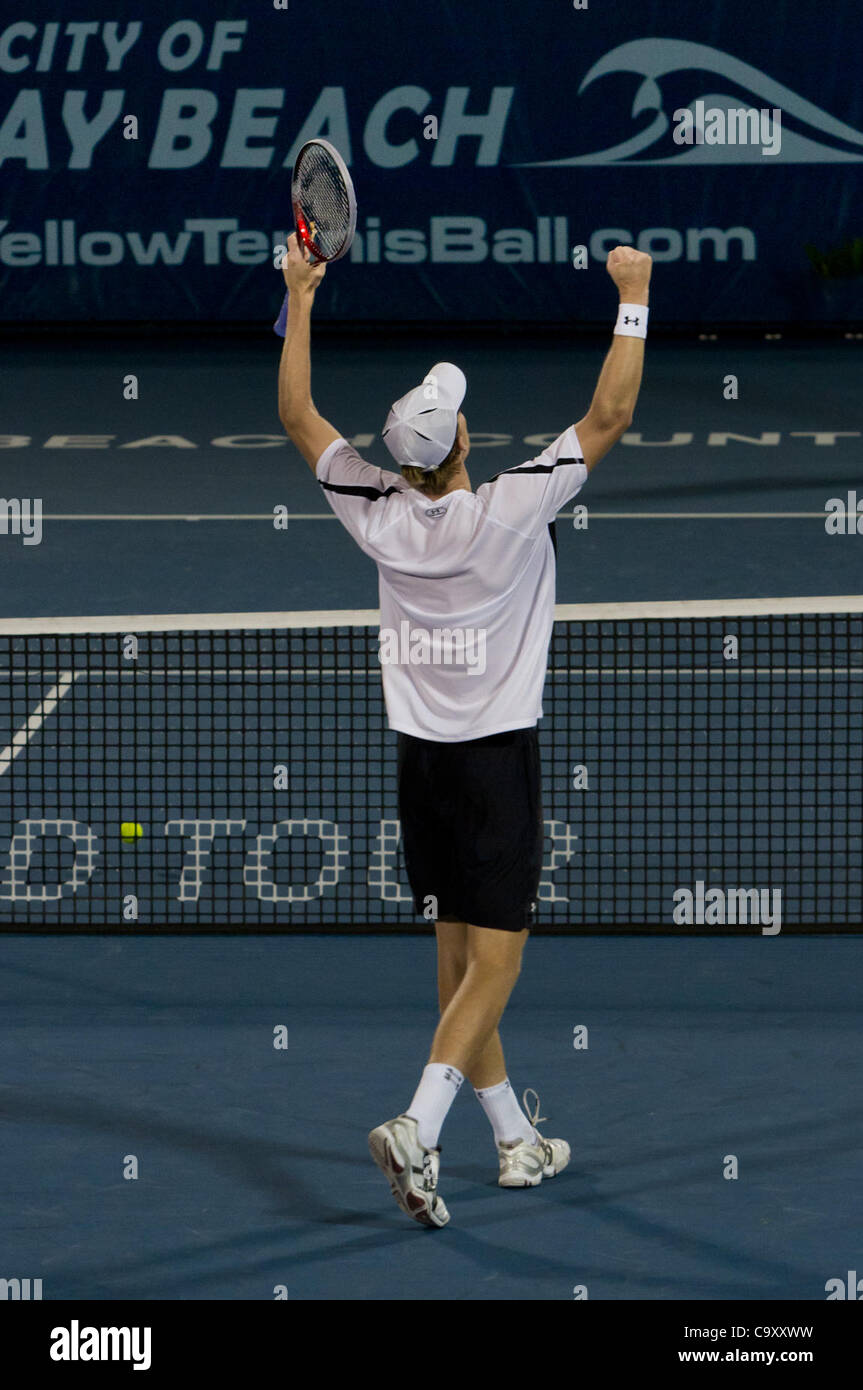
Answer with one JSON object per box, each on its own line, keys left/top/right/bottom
{"left": 315, "top": 425, "right": 588, "bottom": 744}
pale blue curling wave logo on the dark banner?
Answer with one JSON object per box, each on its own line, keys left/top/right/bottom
{"left": 520, "top": 39, "right": 863, "bottom": 168}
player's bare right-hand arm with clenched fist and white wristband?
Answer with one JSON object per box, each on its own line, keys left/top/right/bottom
{"left": 575, "top": 246, "right": 653, "bottom": 468}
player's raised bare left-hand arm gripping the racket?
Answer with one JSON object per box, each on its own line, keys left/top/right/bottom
{"left": 279, "top": 232, "right": 339, "bottom": 473}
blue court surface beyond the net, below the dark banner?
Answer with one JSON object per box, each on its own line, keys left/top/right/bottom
{"left": 0, "top": 325, "right": 863, "bottom": 617}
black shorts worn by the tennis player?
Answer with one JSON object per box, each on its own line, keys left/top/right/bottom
{"left": 399, "top": 728, "right": 543, "bottom": 931}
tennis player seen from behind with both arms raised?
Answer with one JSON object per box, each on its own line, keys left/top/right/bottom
{"left": 279, "top": 236, "right": 652, "bottom": 1226}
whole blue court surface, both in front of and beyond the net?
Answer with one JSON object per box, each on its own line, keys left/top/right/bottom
{"left": 0, "top": 334, "right": 863, "bottom": 1301}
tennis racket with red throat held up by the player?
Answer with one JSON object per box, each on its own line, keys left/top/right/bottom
{"left": 272, "top": 140, "right": 357, "bottom": 338}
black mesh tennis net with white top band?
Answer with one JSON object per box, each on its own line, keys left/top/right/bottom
{"left": 0, "top": 598, "right": 863, "bottom": 931}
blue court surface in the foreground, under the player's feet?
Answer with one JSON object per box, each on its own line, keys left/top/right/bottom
{"left": 0, "top": 935, "right": 863, "bottom": 1301}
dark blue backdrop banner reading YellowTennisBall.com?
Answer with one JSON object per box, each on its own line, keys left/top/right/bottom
{"left": 0, "top": 0, "right": 863, "bottom": 322}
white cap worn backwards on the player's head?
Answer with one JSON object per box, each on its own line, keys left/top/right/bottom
{"left": 384, "top": 361, "right": 467, "bottom": 473}
